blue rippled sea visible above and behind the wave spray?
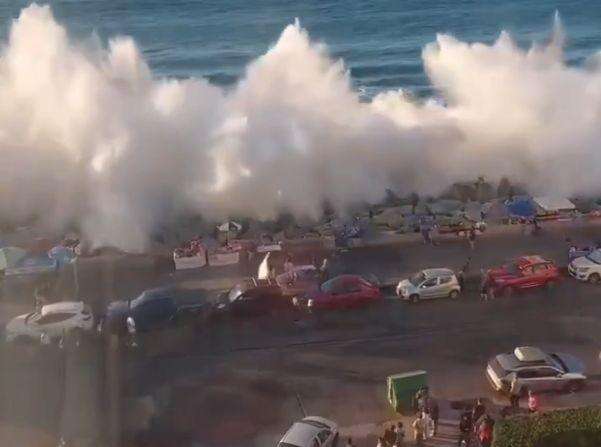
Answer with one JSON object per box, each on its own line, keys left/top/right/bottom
{"left": 0, "top": 0, "right": 601, "bottom": 97}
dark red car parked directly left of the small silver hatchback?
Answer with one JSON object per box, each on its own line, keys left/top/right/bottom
{"left": 300, "top": 275, "right": 382, "bottom": 310}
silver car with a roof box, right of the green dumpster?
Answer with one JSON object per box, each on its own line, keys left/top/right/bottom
{"left": 486, "top": 346, "right": 586, "bottom": 394}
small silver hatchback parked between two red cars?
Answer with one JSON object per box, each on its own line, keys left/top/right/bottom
{"left": 396, "top": 268, "right": 461, "bottom": 302}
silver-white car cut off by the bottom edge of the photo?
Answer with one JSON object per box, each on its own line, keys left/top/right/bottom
{"left": 278, "top": 416, "right": 338, "bottom": 447}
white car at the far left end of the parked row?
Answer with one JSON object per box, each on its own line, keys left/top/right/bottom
{"left": 6, "top": 301, "right": 94, "bottom": 342}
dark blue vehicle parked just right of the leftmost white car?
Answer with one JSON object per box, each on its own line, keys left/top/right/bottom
{"left": 96, "top": 286, "right": 213, "bottom": 335}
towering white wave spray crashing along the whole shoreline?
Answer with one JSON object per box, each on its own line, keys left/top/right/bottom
{"left": 0, "top": 5, "right": 601, "bottom": 250}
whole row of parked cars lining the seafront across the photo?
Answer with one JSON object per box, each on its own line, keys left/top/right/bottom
{"left": 6, "top": 249, "right": 601, "bottom": 348}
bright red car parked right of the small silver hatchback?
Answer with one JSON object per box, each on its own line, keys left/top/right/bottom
{"left": 488, "top": 255, "right": 561, "bottom": 296}
